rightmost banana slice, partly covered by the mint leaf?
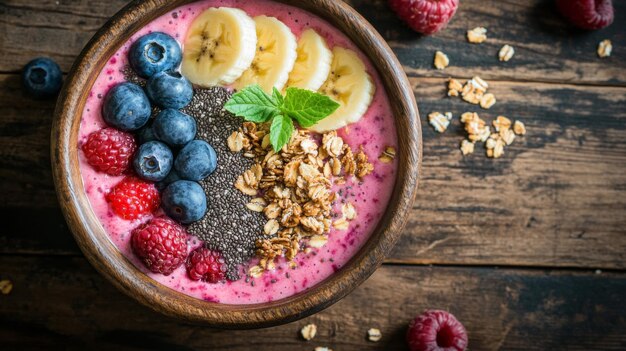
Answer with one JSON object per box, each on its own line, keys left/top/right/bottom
{"left": 309, "top": 47, "right": 376, "bottom": 133}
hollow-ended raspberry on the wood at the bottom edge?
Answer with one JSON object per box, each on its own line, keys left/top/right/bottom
{"left": 406, "top": 310, "right": 467, "bottom": 351}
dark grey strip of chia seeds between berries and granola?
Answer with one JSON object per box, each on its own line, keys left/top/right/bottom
{"left": 182, "top": 87, "right": 266, "bottom": 280}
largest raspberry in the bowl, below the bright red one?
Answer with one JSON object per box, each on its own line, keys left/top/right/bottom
{"left": 130, "top": 217, "right": 187, "bottom": 275}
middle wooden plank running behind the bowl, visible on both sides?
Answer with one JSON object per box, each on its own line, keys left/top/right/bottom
{"left": 0, "top": 75, "right": 626, "bottom": 269}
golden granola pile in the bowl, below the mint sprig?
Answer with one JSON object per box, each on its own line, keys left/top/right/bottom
{"left": 227, "top": 122, "right": 370, "bottom": 277}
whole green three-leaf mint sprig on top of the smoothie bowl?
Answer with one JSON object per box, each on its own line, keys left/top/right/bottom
{"left": 224, "top": 85, "right": 339, "bottom": 152}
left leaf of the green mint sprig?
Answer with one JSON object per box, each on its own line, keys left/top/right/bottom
{"left": 224, "top": 85, "right": 282, "bottom": 123}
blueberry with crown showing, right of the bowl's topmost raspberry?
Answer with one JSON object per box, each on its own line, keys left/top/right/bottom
{"left": 133, "top": 141, "right": 174, "bottom": 182}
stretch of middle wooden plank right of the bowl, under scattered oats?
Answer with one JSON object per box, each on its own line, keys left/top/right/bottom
{"left": 393, "top": 79, "right": 626, "bottom": 268}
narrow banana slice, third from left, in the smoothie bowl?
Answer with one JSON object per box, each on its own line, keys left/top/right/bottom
{"left": 287, "top": 29, "right": 333, "bottom": 91}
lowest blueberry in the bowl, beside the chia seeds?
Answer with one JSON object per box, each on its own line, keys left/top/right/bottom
{"left": 161, "top": 180, "right": 206, "bottom": 224}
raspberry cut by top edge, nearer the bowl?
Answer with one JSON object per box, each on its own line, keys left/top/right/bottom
{"left": 389, "top": 0, "right": 459, "bottom": 35}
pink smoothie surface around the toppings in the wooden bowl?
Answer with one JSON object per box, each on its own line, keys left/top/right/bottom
{"left": 79, "top": 0, "right": 397, "bottom": 304}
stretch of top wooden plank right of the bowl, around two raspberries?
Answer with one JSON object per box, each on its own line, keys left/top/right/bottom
{"left": 350, "top": 0, "right": 626, "bottom": 86}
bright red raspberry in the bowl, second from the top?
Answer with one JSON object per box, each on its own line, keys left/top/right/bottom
{"left": 106, "top": 177, "right": 161, "bottom": 219}
